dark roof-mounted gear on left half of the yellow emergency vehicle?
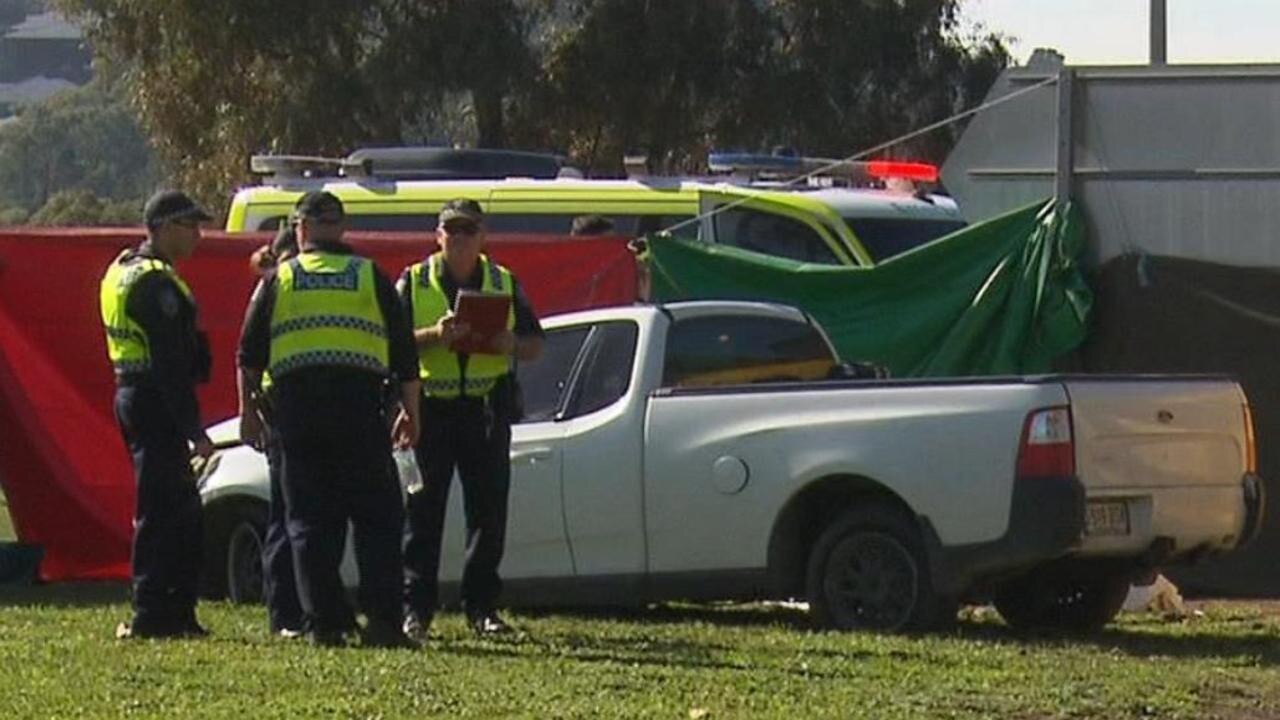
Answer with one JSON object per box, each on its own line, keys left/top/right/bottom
{"left": 250, "top": 147, "right": 566, "bottom": 181}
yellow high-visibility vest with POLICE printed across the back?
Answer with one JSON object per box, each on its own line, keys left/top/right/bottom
{"left": 268, "top": 252, "right": 389, "bottom": 380}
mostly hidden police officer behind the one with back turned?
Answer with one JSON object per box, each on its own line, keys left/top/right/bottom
{"left": 251, "top": 225, "right": 302, "bottom": 638}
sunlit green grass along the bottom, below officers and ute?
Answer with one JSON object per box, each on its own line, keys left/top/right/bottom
{"left": 0, "top": 594, "right": 1280, "bottom": 720}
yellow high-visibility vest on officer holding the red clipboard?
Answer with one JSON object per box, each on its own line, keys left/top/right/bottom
{"left": 410, "top": 252, "right": 516, "bottom": 398}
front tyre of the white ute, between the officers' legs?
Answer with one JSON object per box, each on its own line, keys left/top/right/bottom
{"left": 204, "top": 502, "right": 266, "bottom": 603}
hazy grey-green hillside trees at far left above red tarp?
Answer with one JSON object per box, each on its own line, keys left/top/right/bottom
{"left": 0, "top": 79, "right": 156, "bottom": 224}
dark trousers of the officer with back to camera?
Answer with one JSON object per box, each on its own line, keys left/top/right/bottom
{"left": 276, "top": 370, "right": 404, "bottom": 633}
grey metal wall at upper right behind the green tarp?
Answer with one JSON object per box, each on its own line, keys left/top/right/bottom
{"left": 942, "top": 54, "right": 1280, "bottom": 266}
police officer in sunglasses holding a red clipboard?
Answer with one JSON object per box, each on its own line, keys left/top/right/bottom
{"left": 397, "top": 200, "right": 543, "bottom": 635}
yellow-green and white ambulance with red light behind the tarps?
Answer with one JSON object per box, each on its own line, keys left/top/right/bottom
{"left": 227, "top": 147, "right": 964, "bottom": 266}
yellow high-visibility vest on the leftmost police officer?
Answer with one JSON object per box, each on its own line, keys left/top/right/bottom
{"left": 99, "top": 250, "right": 196, "bottom": 374}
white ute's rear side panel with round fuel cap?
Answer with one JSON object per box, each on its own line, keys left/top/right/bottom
{"left": 645, "top": 383, "right": 1064, "bottom": 571}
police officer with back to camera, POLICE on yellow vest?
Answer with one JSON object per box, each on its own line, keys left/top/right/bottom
{"left": 238, "top": 191, "right": 420, "bottom": 647}
